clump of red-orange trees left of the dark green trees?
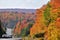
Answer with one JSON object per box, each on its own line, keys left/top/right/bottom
{"left": 14, "top": 20, "right": 29, "bottom": 34}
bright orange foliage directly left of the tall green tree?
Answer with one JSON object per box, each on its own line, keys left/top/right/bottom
{"left": 30, "top": 9, "right": 46, "bottom": 36}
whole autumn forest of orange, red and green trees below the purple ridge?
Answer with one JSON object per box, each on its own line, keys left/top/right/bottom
{"left": 0, "top": 0, "right": 60, "bottom": 40}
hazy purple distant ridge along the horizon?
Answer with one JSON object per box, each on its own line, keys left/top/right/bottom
{"left": 0, "top": 9, "right": 36, "bottom": 13}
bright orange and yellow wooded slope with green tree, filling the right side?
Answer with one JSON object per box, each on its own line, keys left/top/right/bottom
{"left": 30, "top": 0, "right": 60, "bottom": 40}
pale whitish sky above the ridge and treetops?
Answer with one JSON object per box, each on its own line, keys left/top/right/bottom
{"left": 0, "top": 0, "right": 49, "bottom": 9}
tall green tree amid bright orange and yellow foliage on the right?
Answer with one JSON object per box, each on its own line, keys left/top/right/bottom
{"left": 44, "top": 4, "right": 51, "bottom": 26}
